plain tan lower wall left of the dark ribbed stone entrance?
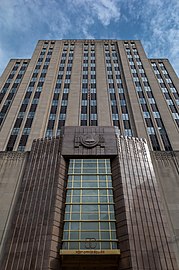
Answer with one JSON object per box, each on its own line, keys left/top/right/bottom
{"left": 0, "top": 152, "right": 28, "bottom": 265}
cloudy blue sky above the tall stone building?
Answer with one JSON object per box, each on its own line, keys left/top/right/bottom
{"left": 0, "top": 0, "right": 179, "bottom": 74}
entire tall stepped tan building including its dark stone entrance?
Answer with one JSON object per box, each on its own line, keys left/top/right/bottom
{"left": 0, "top": 40, "right": 179, "bottom": 270}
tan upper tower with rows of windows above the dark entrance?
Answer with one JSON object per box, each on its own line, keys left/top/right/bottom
{"left": 0, "top": 40, "right": 179, "bottom": 151}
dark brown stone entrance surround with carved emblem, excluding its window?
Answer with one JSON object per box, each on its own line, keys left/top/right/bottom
{"left": 2, "top": 127, "right": 178, "bottom": 270}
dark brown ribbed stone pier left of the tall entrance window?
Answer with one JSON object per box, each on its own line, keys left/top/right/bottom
{"left": 1, "top": 138, "right": 66, "bottom": 270}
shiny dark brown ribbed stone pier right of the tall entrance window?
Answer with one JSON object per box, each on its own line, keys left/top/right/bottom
{"left": 113, "top": 136, "right": 178, "bottom": 270}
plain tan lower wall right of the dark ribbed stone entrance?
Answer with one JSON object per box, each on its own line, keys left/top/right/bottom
{"left": 151, "top": 151, "right": 179, "bottom": 265}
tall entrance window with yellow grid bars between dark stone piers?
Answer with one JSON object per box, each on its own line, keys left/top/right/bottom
{"left": 62, "top": 159, "right": 118, "bottom": 250}
